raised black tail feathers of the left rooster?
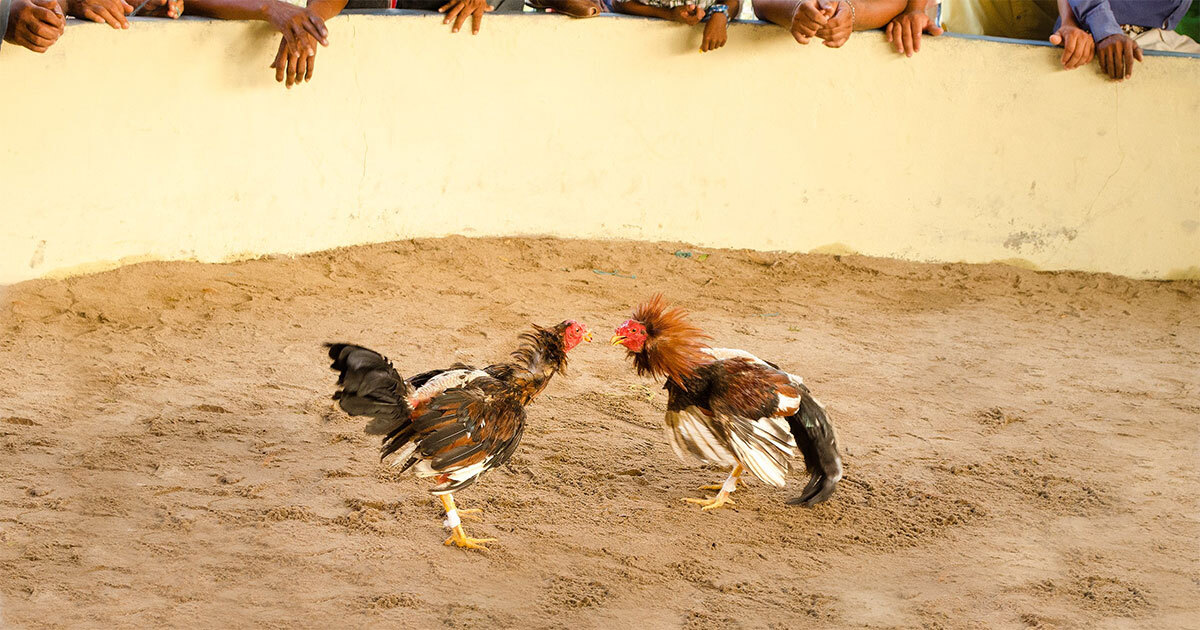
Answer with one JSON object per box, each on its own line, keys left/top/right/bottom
{"left": 325, "top": 343, "right": 412, "bottom": 436}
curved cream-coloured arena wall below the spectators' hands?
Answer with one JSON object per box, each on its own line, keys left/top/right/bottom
{"left": 0, "top": 16, "right": 1200, "bottom": 283}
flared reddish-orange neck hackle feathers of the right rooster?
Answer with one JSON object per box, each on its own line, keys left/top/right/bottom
{"left": 632, "top": 294, "right": 712, "bottom": 386}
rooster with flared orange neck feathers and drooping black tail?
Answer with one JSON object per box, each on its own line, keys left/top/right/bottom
{"left": 612, "top": 295, "right": 841, "bottom": 510}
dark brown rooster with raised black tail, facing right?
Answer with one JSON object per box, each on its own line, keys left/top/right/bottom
{"left": 326, "top": 319, "right": 592, "bottom": 550}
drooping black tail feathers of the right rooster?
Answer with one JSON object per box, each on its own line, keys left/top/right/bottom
{"left": 787, "top": 385, "right": 842, "bottom": 508}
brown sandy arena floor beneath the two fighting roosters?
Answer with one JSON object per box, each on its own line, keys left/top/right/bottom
{"left": 0, "top": 238, "right": 1200, "bottom": 629}
